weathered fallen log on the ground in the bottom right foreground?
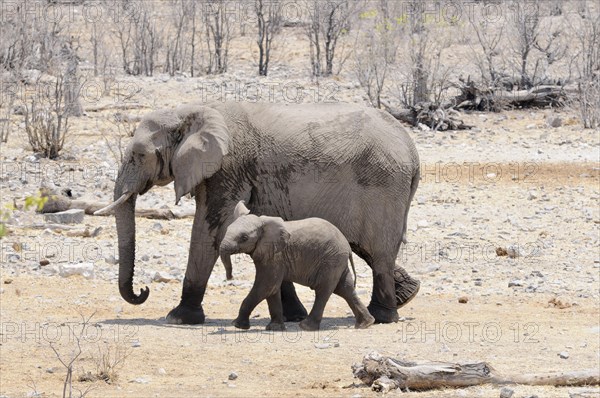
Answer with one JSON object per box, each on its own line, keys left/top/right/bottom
{"left": 352, "top": 352, "right": 600, "bottom": 392}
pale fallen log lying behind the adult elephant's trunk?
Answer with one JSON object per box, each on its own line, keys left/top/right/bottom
{"left": 39, "top": 188, "right": 195, "bottom": 220}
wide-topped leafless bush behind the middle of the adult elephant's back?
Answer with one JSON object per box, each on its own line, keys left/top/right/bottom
{"left": 306, "top": 0, "right": 362, "bottom": 76}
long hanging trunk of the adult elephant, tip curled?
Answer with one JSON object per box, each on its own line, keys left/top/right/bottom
{"left": 114, "top": 181, "right": 150, "bottom": 304}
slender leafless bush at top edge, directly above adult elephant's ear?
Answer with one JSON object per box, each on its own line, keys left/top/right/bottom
{"left": 203, "top": 0, "right": 234, "bottom": 74}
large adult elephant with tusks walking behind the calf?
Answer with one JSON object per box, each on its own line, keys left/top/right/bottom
{"left": 100, "top": 102, "right": 419, "bottom": 324}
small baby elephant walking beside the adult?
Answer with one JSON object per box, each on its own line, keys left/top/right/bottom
{"left": 221, "top": 202, "right": 375, "bottom": 330}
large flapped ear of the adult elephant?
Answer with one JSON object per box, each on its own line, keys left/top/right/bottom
{"left": 171, "top": 105, "right": 230, "bottom": 203}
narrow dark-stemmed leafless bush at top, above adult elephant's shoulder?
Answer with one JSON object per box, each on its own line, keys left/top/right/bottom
{"left": 254, "top": 0, "right": 282, "bottom": 76}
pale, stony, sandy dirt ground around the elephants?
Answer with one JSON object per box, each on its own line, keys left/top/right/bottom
{"left": 0, "top": 103, "right": 600, "bottom": 397}
